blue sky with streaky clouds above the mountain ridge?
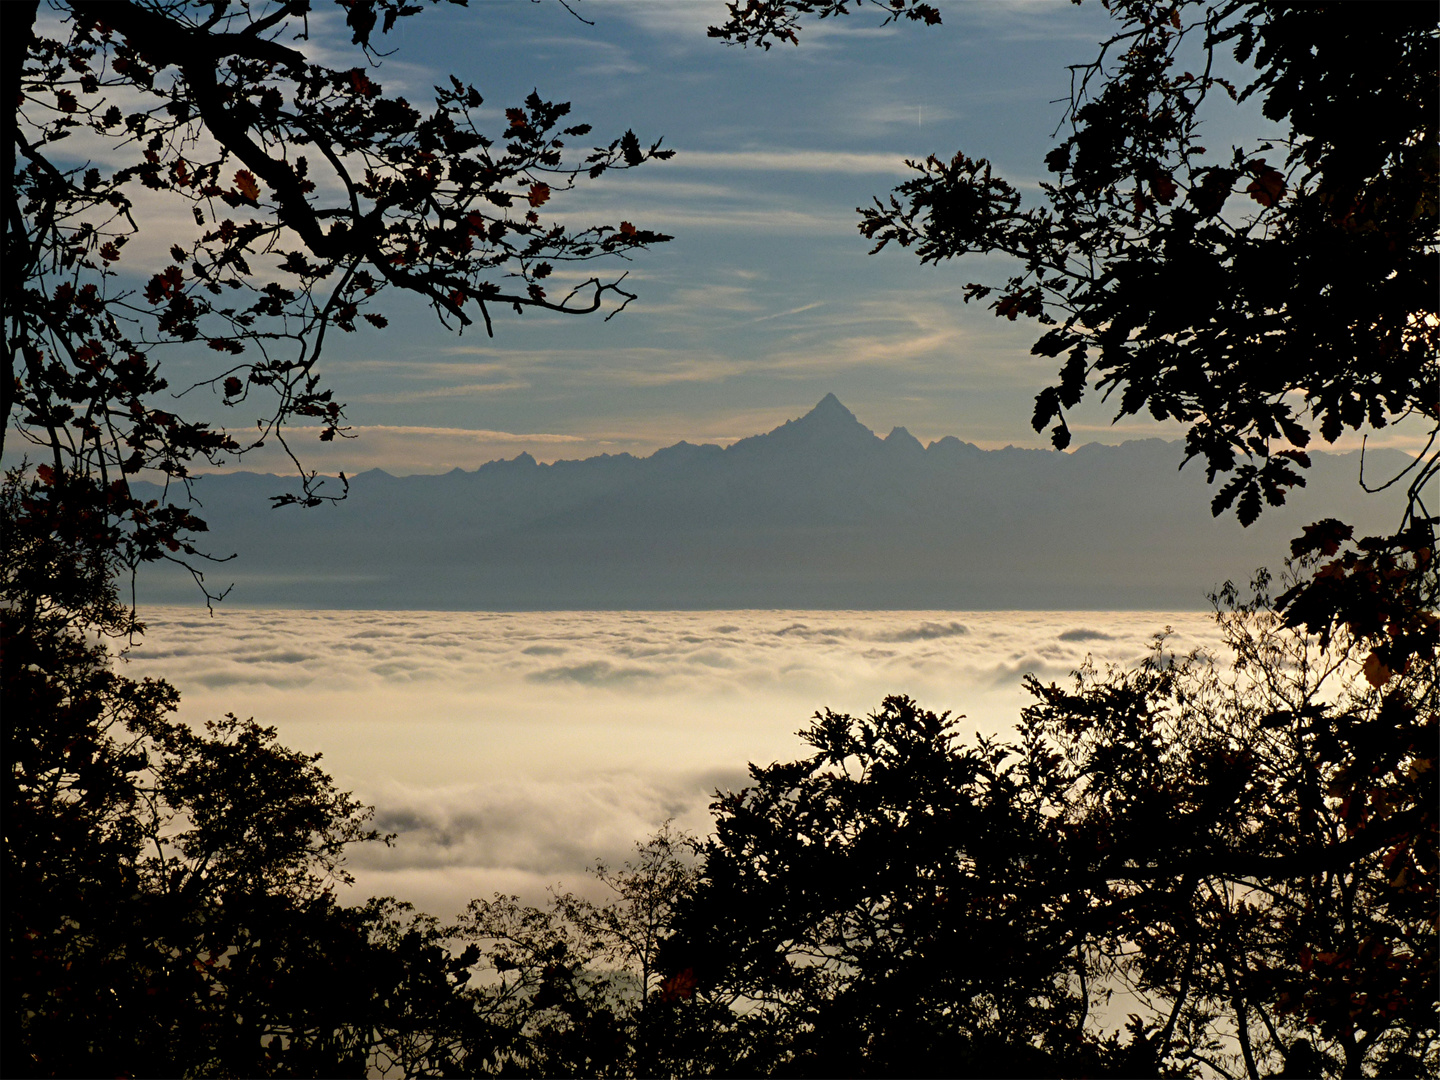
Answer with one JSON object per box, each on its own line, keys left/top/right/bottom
{"left": 106, "top": 0, "right": 1290, "bottom": 474}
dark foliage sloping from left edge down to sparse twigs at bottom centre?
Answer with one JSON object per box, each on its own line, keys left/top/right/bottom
{"left": 0, "top": 486, "right": 714, "bottom": 1077}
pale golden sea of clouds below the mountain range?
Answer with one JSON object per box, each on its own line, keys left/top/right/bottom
{"left": 125, "top": 606, "right": 1220, "bottom": 917}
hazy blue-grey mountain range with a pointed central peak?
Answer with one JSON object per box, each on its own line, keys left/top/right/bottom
{"left": 141, "top": 395, "right": 1404, "bottom": 611}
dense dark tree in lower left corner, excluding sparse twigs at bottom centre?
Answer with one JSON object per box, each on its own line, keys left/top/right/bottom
{"left": 0, "top": 472, "right": 492, "bottom": 1076}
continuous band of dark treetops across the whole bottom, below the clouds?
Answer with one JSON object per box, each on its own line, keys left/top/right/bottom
{"left": 16, "top": 544, "right": 1422, "bottom": 1077}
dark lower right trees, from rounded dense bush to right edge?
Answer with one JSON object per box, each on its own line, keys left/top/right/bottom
{"left": 665, "top": 582, "right": 1440, "bottom": 1080}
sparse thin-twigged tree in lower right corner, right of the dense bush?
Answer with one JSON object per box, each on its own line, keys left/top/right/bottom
{"left": 1027, "top": 582, "right": 1440, "bottom": 1076}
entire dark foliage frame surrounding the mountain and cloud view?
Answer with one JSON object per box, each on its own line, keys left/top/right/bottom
{"left": 0, "top": 0, "right": 1440, "bottom": 1080}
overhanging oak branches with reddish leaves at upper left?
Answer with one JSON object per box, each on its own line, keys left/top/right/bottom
{"left": 0, "top": 0, "right": 671, "bottom": 593}
